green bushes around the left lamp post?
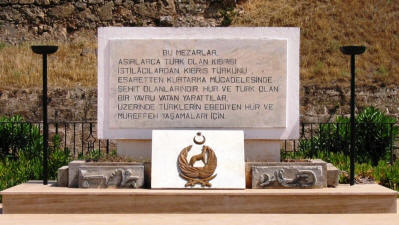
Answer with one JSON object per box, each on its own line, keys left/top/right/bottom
{"left": 0, "top": 117, "right": 72, "bottom": 200}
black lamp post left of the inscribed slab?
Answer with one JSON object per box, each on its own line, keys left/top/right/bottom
{"left": 31, "top": 45, "right": 58, "bottom": 185}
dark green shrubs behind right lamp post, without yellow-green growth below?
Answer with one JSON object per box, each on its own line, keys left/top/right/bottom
{"left": 299, "top": 107, "right": 398, "bottom": 166}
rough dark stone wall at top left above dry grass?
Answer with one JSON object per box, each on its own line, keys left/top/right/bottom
{"left": 0, "top": 0, "right": 236, "bottom": 43}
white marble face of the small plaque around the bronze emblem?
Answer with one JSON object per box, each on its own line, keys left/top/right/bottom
{"left": 151, "top": 130, "right": 245, "bottom": 189}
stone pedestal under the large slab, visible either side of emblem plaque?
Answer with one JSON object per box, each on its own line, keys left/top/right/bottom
{"left": 117, "top": 139, "right": 281, "bottom": 162}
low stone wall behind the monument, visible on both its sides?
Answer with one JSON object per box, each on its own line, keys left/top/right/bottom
{"left": 0, "top": 86, "right": 399, "bottom": 123}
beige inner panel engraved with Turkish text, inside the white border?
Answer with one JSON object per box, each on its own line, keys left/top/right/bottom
{"left": 108, "top": 39, "right": 287, "bottom": 128}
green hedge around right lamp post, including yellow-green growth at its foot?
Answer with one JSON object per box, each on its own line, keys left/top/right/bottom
{"left": 281, "top": 107, "right": 399, "bottom": 191}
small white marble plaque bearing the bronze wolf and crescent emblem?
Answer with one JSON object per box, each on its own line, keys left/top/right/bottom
{"left": 151, "top": 130, "right": 245, "bottom": 189}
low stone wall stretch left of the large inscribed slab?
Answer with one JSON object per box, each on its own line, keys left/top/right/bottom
{"left": 0, "top": 88, "right": 97, "bottom": 121}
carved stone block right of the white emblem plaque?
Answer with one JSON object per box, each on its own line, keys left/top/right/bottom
{"left": 252, "top": 163, "right": 327, "bottom": 188}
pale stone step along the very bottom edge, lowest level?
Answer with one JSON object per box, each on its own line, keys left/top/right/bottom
{"left": 0, "top": 214, "right": 399, "bottom": 225}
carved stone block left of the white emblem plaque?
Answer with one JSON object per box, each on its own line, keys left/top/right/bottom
{"left": 79, "top": 164, "right": 144, "bottom": 188}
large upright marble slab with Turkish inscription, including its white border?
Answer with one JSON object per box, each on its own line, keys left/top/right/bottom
{"left": 98, "top": 27, "right": 299, "bottom": 140}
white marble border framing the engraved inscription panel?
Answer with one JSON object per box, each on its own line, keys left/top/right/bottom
{"left": 98, "top": 27, "right": 299, "bottom": 140}
